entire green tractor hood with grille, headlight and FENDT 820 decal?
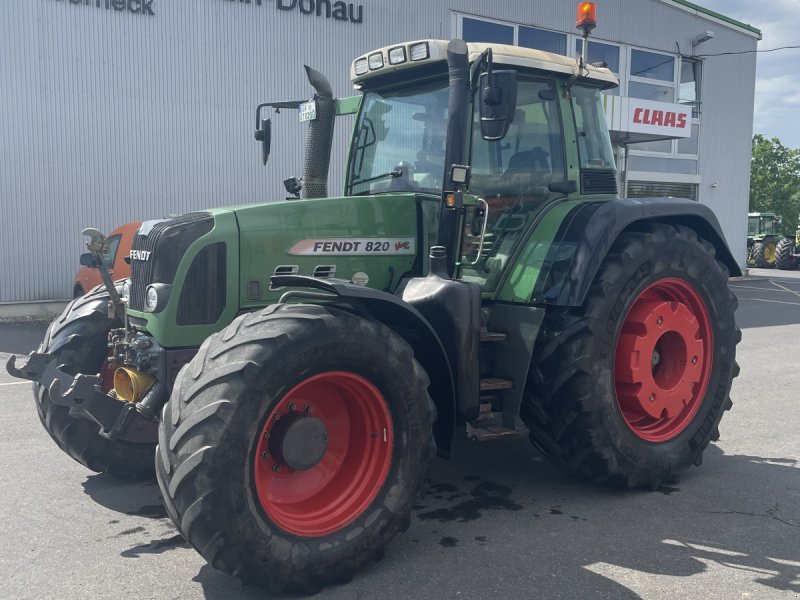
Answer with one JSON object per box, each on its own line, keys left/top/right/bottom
{"left": 129, "top": 193, "right": 440, "bottom": 347}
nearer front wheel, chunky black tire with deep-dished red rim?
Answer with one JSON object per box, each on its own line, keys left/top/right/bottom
{"left": 156, "top": 305, "right": 434, "bottom": 592}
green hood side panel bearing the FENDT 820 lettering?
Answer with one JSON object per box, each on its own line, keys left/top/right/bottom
{"left": 234, "top": 194, "right": 424, "bottom": 309}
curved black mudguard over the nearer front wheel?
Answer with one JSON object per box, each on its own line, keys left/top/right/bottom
{"left": 271, "top": 275, "right": 456, "bottom": 458}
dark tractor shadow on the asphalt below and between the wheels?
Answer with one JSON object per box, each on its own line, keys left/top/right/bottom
{"left": 181, "top": 440, "right": 800, "bottom": 600}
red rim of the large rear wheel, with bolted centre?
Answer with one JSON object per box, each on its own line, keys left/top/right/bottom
{"left": 614, "top": 279, "right": 714, "bottom": 442}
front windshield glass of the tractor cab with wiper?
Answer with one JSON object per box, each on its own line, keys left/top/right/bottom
{"left": 347, "top": 80, "right": 448, "bottom": 195}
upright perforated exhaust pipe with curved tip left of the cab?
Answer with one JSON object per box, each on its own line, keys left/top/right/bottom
{"left": 302, "top": 65, "right": 336, "bottom": 198}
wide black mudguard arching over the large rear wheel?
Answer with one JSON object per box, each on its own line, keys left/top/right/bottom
{"left": 531, "top": 198, "right": 742, "bottom": 306}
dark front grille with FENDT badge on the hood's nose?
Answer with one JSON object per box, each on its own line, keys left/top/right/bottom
{"left": 130, "top": 213, "right": 214, "bottom": 311}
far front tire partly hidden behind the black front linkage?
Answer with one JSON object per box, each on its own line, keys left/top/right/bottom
{"left": 33, "top": 291, "right": 156, "bottom": 479}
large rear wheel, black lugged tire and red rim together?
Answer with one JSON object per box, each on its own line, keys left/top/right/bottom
{"left": 522, "top": 224, "right": 741, "bottom": 489}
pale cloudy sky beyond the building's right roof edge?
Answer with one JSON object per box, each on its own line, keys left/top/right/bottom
{"left": 693, "top": 0, "right": 800, "bottom": 148}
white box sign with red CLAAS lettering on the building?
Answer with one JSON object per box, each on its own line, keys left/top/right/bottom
{"left": 604, "top": 96, "right": 692, "bottom": 141}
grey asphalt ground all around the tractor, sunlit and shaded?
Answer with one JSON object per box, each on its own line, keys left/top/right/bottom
{"left": 0, "top": 271, "right": 800, "bottom": 600}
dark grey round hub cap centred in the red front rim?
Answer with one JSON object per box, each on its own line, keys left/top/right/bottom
{"left": 269, "top": 412, "right": 328, "bottom": 471}
